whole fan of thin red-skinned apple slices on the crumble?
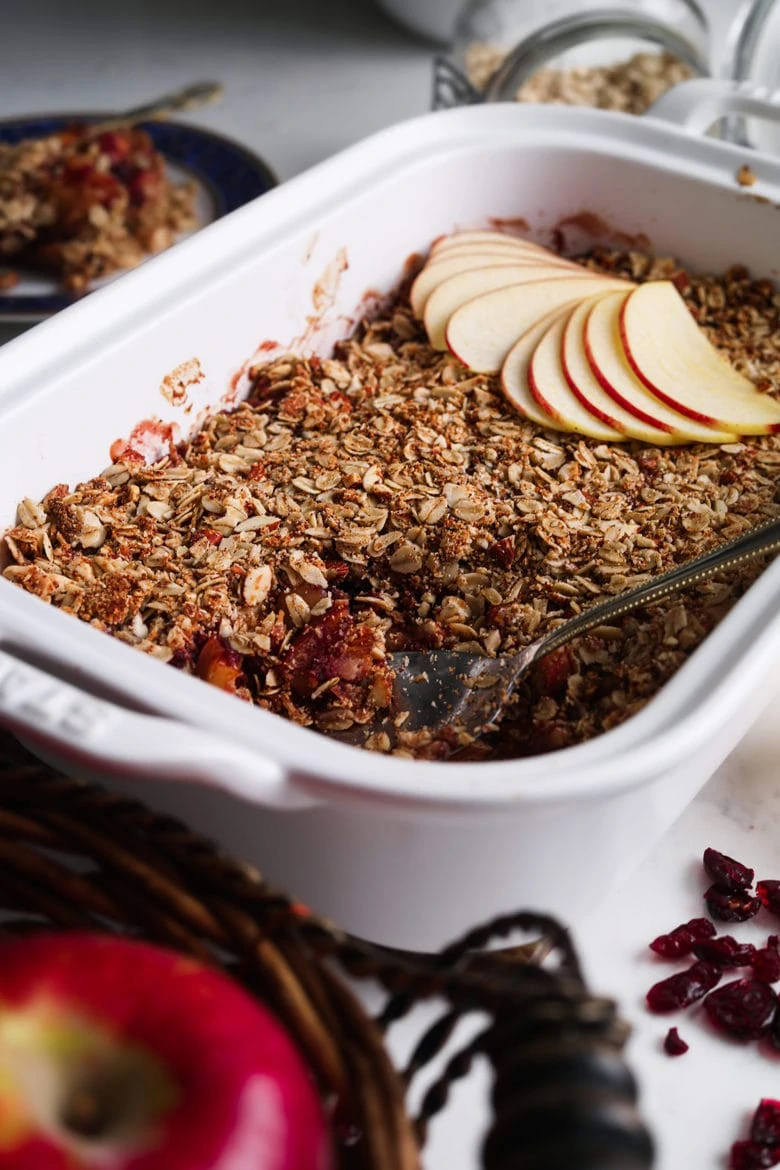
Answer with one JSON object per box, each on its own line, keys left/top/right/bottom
{"left": 410, "top": 230, "right": 780, "bottom": 445}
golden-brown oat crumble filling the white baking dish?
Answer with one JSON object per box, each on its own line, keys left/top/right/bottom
{"left": 5, "top": 249, "right": 780, "bottom": 758}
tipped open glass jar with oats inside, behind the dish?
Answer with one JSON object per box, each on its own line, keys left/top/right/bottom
{"left": 435, "top": 0, "right": 710, "bottom": 113}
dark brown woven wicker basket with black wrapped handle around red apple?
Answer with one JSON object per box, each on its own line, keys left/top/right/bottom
{"left": 0, "top": 732, "right": 651, "bottom": 1170}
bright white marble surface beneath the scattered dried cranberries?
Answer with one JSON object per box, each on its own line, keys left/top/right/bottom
{"left": 376, "top": 674, "right": 780, "bottom": 1170}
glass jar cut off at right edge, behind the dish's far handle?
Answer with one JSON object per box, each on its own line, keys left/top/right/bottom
{"left": 730, "top": 0, "right": 780, "bottom": 154}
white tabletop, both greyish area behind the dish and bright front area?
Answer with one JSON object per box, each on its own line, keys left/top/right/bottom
{"left": 0, "top": 0, "right": 780, "bottom": 1170}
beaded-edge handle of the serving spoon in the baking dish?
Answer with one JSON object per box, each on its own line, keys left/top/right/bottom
{"left": 524, "top": 519, "right": 780, "bottom": 668}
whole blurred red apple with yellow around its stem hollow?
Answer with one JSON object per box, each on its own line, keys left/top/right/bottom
{"left": 0, "top": 932, "right": 332, "bottom": 1170}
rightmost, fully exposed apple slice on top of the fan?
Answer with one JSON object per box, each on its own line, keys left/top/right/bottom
{"left": 619, "top": 281, "right": 780, "bottom": 434}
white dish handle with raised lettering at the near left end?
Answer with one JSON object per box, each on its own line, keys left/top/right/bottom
{"left": 0, "top": 649, "right": 317, "bottom": 810}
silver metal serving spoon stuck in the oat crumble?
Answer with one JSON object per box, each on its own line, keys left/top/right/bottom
{"left": 350, "top": 519, "right": 780, "bottom": 744}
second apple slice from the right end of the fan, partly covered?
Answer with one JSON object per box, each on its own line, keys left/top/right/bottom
{"left": 584, "top": 293, "right": 743, "bottom": 442}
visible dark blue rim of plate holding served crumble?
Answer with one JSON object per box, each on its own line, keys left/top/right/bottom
{"left": 0, "top": 113, "right": 277, "bottom": 322}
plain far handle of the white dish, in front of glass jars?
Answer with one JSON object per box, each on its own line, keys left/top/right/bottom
{"left": 646, "top": 77, "right": 780, "bottom": 135}
